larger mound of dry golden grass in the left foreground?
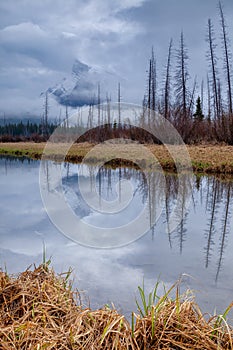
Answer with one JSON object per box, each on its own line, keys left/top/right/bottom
{"left": 0, "top": 265, "right": 132, "bottom": 350}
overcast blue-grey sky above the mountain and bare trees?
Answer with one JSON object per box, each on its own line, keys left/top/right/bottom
{"left": 0, "top": 0, "right": 233, "bottom": 118}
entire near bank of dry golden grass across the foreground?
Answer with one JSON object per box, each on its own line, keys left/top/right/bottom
{"left": 0, "top": 264, "right": 233, "bottom": 350}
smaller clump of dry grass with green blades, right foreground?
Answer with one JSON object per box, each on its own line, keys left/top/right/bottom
{"left": 134, "top": 299, "right": 233, "bottom": 350}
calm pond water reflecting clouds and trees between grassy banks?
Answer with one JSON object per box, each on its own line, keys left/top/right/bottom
{"left": 0, "top": 158, "right": 233, "bottom": 317}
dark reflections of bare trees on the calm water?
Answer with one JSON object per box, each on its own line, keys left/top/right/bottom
{"left": 41, "top": 160, "right": 233, "bottom": 282}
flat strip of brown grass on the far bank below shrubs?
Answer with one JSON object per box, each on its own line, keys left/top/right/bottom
{"left": 0, "top": 142, "right": 233, "bottom": 174}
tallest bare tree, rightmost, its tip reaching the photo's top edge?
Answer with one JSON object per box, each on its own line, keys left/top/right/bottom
{"left": 218, "top": 1, "right": 232, "bottom": 114}
